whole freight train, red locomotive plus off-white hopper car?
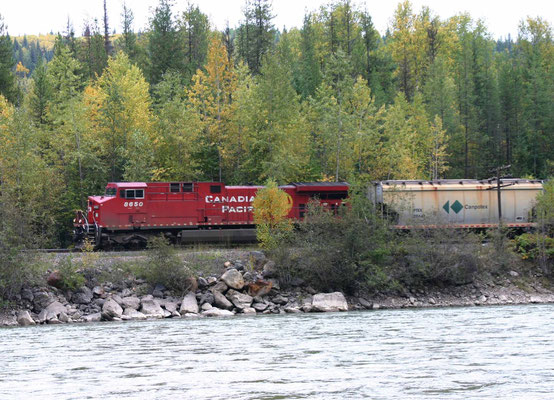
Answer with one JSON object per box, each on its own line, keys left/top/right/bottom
{"left": 73, "top": 179, "right": 543, "bottom": 248}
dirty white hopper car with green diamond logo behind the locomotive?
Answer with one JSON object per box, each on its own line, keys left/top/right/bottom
{"left": 368, "top": 179, "right": 543, "bottom": 229}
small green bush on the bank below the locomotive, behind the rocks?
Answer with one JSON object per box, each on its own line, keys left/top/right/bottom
{"left": 140, "top": 236, "right": 192, "bottom": 294}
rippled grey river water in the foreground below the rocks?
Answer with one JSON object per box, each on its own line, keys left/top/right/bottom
{"left": 0, "top": 305, "right": 554, "bottom": 399}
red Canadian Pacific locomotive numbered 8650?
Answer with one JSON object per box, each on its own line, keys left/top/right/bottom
{"left": 73, "top": 182, "right": 348, "bottom": 247}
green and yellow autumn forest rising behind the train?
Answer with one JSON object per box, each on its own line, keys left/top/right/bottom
{"left": 0, "top": 0, "right": 554, "bottom": 246}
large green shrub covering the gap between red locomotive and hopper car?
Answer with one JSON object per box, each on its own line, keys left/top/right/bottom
{"left": 270, "top": 185, "right": 395, "bottom": 293}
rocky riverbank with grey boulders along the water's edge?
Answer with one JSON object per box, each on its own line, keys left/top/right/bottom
{"left": 0, "top": 251, "right": 554, "bottom": 326}
